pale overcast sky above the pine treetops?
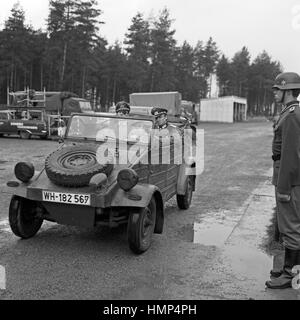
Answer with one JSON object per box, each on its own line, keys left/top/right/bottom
{"left": 0, "top": 0, "right": 300, "bottom": 73}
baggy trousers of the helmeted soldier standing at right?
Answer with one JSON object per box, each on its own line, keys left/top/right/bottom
{"left": 276, "top": 186, "right": 300, "bottom": 250}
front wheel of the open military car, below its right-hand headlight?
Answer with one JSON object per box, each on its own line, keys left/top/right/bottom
{"left": 127, "top": 198, "right": 156, "bottom": 254}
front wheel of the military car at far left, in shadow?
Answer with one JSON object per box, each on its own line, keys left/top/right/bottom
{"left": 9, "top": 196, "right": 43, "bottom": 239}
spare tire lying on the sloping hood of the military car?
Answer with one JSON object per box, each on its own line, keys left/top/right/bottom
{"left": 45, "top": 144, "right": 113, "bottom": 187}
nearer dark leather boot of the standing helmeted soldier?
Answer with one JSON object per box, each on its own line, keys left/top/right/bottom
{"left": 266, "top": 248, "right": 300, "bottom": 289}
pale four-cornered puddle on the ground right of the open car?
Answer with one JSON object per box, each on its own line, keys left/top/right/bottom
{"left": 193, "top": 222, "right": 234, "bottom": 246}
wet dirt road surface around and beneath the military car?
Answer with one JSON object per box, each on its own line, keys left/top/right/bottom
{"left": 0, "top": 122, "right": 296, "bottom": 299}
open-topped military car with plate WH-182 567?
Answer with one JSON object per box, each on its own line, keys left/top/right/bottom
{"left": 7, "top": 114, "right": 195, "bottom": 254}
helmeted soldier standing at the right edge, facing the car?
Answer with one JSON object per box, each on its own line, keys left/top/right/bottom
{"left": 266, "top": 72, "right": 300, "bottom": 289}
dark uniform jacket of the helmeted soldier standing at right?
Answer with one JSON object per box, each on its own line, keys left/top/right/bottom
{"left": 272, "top": 101, "right": 300, "bottom": 195}
